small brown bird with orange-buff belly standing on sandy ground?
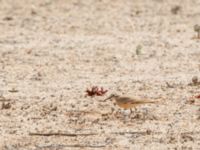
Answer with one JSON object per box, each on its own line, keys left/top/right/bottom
{"left": 104, "top": 94, "right": 158, "bottom": 112}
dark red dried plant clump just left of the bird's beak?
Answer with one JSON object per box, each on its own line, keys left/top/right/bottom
{"left": 85, "top": 86, "right": 108, "bottom": 97}
